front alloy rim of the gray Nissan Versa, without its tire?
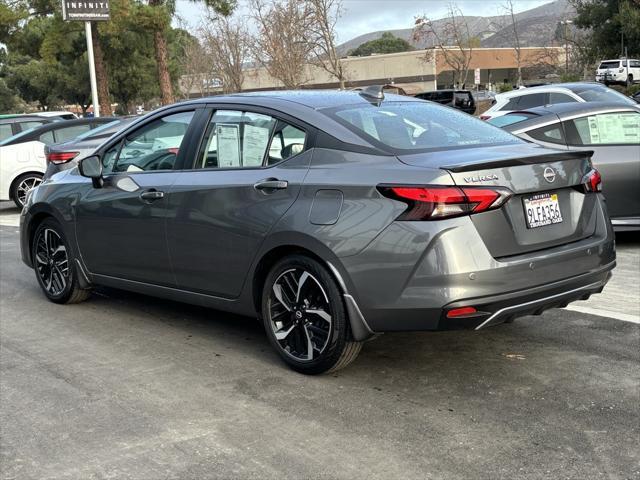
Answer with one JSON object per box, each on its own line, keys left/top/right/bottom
{"left": 35, "top": 228, "right": 70, "bottom": 297}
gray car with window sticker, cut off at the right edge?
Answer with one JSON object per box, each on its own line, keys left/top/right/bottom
{"left": 489, "top": 102, "right": 640, "bottom": 231}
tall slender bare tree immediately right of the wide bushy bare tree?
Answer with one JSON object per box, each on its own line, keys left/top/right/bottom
{"left": 308, "top": 0, "right": 346, "bottom": 89}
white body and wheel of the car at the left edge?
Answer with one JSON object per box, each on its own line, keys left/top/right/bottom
{"left": 0, "top": 141, "right": 47, "bottom": 208}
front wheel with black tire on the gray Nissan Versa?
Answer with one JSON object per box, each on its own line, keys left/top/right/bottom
{"left": 31, "top": 218, "right": 91, "bottom": 303}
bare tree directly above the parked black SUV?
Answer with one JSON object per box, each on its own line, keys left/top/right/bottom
{"left": 413, "top": 3, "right": 477, "bottom": 86}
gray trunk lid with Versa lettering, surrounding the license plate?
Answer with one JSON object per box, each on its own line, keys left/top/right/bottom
{"left": 399, "top": 144, "right": 597, "bottom": 258}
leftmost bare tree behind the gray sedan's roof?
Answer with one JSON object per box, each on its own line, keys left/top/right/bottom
{"left": 201, "top": 16, "right": 253, "bottom": 93}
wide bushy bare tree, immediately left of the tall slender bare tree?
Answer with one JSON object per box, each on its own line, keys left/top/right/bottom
{"left": 251, "top": 0, "right": 316, "bottom": 89}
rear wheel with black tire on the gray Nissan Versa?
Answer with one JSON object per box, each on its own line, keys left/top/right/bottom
{"left": 262, "top": 255, "right": 362, "bottom": 375}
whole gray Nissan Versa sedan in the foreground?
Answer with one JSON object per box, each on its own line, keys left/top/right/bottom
{"left": 21, "top": 87, "right": 615, "bottom": 374}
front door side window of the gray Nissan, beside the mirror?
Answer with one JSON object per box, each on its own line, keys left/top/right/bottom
{"left": 110, "top": 111, "right": 194, "bottom": 172}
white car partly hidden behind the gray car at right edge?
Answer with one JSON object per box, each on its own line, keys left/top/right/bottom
{"left": 480, "top": 82, "right": 636, "bottom": 120}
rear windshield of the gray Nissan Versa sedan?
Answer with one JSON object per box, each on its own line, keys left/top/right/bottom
{"left": 323, "top": 102, "right": 522, "bottom": 153}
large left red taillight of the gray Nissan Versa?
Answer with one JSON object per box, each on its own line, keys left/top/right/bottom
{"left": 378, "top": 185, "right": 513, "bottom": 220}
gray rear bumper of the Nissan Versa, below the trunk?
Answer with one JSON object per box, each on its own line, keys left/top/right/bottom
{"left": 341, "top": 197, "right": 615, "bottom": 332}
